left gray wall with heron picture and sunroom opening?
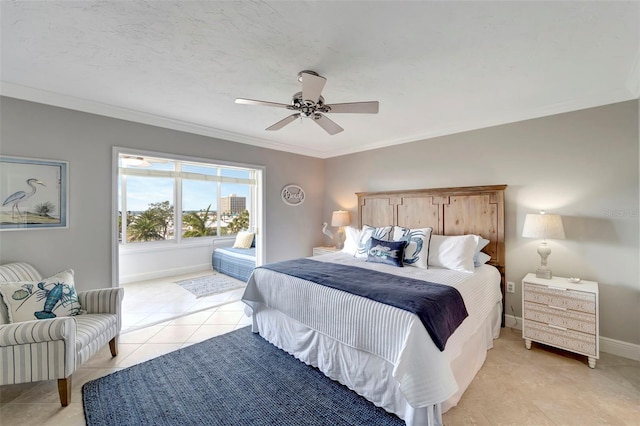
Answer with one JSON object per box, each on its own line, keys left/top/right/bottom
{"left": 0, "top": 97, "right": 324, "bottom": 290}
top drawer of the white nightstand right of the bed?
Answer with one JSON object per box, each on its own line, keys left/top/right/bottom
{"left": 524, "top": 283, "right": 596, "bottom": 314}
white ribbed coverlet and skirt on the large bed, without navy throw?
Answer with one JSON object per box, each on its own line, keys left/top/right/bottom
{"left": 243, "top": 253, "right": 502, "bottom": 420}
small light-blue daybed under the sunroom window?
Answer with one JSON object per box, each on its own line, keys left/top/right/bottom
{"left": 211, "top": 237, "right": 256, "bottom": 282}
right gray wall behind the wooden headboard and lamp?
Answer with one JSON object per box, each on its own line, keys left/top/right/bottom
{"left": 324, "top": 101, "right": 640, "bottom": 344}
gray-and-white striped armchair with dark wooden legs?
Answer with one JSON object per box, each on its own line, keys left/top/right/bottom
{"left": 0, "top": 262, "right": 124, "bottom": 407}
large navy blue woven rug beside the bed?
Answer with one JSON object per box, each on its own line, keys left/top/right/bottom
{"left": 82, "top": 327, "right": 404, "bottom": 426}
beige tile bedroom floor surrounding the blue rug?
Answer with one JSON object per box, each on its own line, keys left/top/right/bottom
{"left": 0, "top": 296, "right": 640, "bottom": 426}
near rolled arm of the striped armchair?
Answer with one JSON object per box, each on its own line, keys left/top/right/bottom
{"left": 0, "top": 317, "right": 76, "bottom": 348}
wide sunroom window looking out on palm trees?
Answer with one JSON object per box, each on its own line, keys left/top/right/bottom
{"left": 118, "top": 153, "right": 260, "bottom": 244}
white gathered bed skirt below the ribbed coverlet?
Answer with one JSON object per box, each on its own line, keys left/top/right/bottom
{"left": 252, "top": 304, "right": 502, "bottom": 426}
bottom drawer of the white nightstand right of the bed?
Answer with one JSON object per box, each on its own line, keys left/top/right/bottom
{"left": 523, "top": 321, "right": 597, "bottom": 356}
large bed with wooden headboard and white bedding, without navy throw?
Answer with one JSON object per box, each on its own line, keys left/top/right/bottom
{"left": 243, "top": 185, "right": 506, "bottom": 425}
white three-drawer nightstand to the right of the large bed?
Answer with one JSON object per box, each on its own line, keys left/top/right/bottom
{"left": 522, "top": 274, "right": 600, "bottom": 368}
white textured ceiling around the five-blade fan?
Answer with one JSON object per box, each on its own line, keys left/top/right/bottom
{"left": 0, "top": 1, "right": 640, "bottom": 158}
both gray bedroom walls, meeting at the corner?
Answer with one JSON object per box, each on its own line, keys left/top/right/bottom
{"left": 0, "top": 97, "right": 640, "bottom": 344}
